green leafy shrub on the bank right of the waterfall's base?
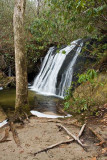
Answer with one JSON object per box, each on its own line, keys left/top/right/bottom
{"left": 64, "top": 69, "right": 103, "bottom": 115}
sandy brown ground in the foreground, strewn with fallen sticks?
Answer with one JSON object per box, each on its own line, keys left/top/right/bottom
{"left": 0, "top": 116, "right": 107, "bottom": 160}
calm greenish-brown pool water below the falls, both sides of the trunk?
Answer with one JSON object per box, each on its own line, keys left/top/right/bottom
{"left": 0, "top": 89, "right": 60, "bottom": 114}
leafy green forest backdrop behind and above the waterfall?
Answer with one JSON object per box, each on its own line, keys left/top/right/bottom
{"left": 0, "top": 0, "right": 107, "bottom": 77}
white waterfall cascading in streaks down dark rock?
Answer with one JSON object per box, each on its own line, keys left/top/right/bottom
{"left": 31, "top": 40, "right": 83, "bottom": 98}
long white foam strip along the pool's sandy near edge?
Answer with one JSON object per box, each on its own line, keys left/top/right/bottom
{"left": 30, "top": 110, "right": 72, "bottom": 118}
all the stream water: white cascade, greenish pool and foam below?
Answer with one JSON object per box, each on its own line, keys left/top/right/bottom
{"left": 0, "top": 40, "right": 83, "bottom": 126}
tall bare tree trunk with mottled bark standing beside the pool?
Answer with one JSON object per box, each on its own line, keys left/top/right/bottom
{"left": 13, "top": 0, "right": 29, "bottom": 113}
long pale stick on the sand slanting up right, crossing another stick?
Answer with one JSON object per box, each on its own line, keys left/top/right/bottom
{"left": 34, "top": 124, "right": 86, "bottom": 156}
